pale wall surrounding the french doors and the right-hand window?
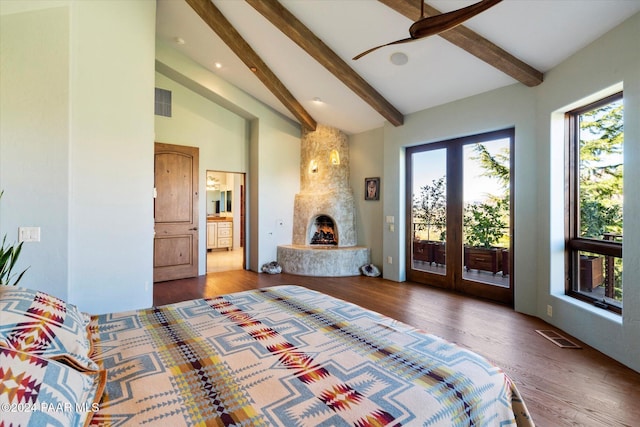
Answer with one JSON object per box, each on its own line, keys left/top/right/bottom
{"left": 373, "top": 15, "right": 640, "bottom": 371}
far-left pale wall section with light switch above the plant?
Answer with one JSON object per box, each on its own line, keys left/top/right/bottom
{"left": 0, "top": 5, "right": 71, "bottom": 298}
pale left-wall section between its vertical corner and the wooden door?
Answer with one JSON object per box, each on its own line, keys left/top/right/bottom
{"left": 69, "top": 0, "right": 155, "bottom": 312}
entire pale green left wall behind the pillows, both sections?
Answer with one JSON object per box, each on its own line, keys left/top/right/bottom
{"left": 0, "top": 0, "right": 155, "bottom": 312}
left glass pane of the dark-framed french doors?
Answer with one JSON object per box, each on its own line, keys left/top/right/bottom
{"left": 409, "top": 148, "right": 447, "bottom": 275}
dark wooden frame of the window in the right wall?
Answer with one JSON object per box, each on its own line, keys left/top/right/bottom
{"left": 565, "top": 91, "right": 624, "bottom": 314}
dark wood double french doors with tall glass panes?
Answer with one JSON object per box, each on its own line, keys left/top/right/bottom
{"left": 406, "top": 129, "right": 514, "bottom": 305}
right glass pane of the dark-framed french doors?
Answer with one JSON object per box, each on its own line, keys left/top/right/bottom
{"left": 462, "top": 138, "right": 511, "bottom": 288}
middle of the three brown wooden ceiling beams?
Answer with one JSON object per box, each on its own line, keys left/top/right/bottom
{"left": 246, "top": 0, "right": 404, "bottom": 126}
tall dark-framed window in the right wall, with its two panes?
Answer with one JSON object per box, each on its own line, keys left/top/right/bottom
{"left": 566, "top": 93, "right": 624, "bottom": 313}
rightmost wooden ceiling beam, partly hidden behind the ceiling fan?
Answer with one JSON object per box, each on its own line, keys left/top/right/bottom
{"left": 378, "top": 0, "right": 543, "bottom": 87}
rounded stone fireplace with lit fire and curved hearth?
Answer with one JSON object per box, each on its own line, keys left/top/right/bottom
{"left": 278, "top": 125, "right": 370, "bottom": 276}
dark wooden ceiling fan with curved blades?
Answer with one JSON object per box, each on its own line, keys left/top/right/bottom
{"left": 353, "top": 0, "right": 502, "bottom": 60}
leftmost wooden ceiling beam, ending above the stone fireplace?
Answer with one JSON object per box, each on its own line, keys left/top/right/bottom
{"left": 186, "top": 0, "right": 317, "bottom": 130}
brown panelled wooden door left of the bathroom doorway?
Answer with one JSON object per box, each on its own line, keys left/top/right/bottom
{"left": 153, "top": 143, "right": 199, "bottom": 282}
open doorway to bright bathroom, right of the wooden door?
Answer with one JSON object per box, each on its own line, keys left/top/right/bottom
{"left": 206, "top": 170, "right": 246, "bottom": 273}
